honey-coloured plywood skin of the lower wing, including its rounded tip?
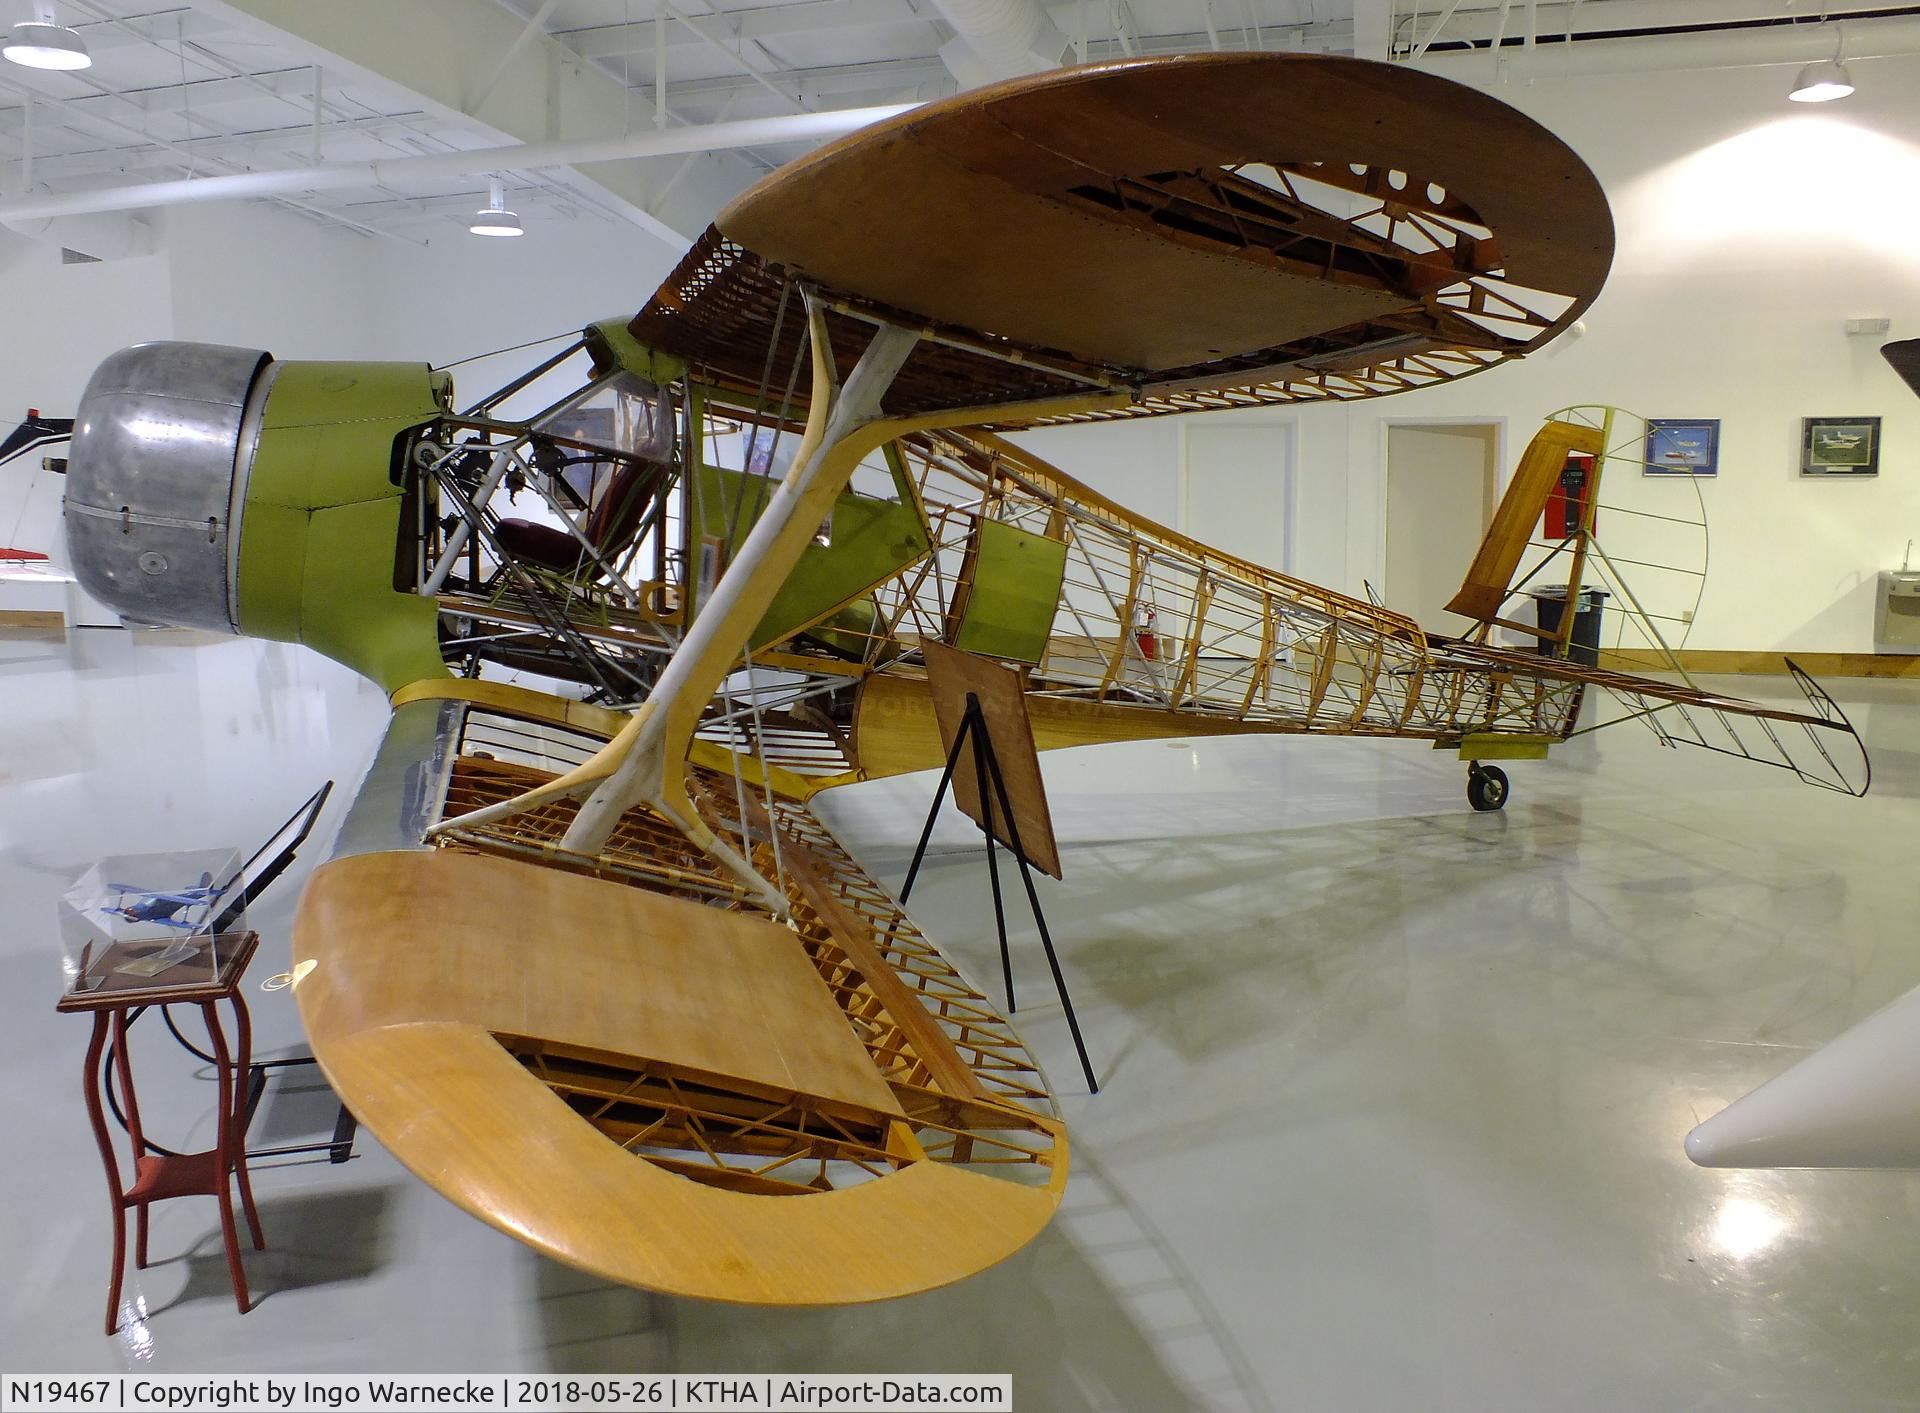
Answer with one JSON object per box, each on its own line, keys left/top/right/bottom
{"left": 294, "top": 850, "right": 1064, "bottom": 1305}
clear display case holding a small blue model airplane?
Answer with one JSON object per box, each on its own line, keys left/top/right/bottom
{"left": 60, "top": 849, "right": 246, "bottom": 1000}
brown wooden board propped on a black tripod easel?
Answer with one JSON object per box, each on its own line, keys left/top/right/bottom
{"left": 922, "top": 641, "right": 1060, "bottom": 877}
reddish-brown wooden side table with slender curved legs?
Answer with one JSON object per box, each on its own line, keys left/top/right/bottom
{"left": 56, "top": 933, "right": 267, "bottom": 1334}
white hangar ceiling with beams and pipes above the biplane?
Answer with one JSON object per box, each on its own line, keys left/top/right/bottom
{"left": 0, "top": 0, "right": 1920, "bottom": 240}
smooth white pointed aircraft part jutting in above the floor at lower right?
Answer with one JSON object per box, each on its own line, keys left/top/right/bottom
{"left": 1686, "top": 987, "right": 1920, "bottom": 1167}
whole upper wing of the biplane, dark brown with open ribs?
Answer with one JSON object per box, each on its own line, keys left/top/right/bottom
{"left": 632, "top": 54, "right": 1613, "bottom": 420}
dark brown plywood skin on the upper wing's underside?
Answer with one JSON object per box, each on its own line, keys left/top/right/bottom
{"left": 716, "top": 54, "right": 1613, "bottom": 371}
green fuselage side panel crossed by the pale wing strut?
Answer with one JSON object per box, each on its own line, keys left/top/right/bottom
{"left": 697, "top": 467, "right": 931, "bottom": 647}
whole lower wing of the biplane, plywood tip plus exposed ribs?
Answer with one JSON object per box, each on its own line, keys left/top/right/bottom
{"left": 307, "top": 682, "right": 1066, "bottom": 1305}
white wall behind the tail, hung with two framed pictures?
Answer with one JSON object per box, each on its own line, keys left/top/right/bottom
{"left": 1023, "top": 58, "right": 1920, "bottom": 653}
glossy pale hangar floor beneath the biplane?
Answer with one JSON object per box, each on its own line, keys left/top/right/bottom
{"left": 0, "top": 632, "right": 1920, "bottom": 1413}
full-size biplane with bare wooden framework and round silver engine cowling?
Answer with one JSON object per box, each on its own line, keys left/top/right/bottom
{"left": 56, "top": 54, "right": 1864, "bottom": 1304}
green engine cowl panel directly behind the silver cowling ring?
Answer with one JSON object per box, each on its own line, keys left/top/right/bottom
{"left": 236, "top": 363, "right": 445, "bottom": 691}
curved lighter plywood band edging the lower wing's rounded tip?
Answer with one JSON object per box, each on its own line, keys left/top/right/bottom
{"left": 315, "top": 1023, "right": 1058, "bottom": 1305}
